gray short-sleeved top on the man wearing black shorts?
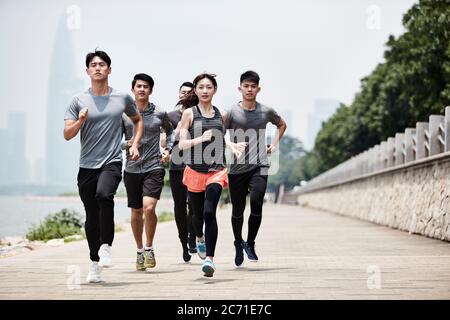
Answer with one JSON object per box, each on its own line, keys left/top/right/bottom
{"left": 123, "top": 103, "right": 173, "bottom": 173}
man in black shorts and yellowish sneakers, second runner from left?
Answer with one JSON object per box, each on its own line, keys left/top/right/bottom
{"left": 124, "top": 73, "right": 172, "bottom": 270}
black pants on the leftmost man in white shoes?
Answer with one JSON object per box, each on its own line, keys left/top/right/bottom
{"left": 78, "top": 162, "right": 122, "bottom": 261}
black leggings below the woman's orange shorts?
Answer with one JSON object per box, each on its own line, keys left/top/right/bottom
{"left": 189, "top": 183, "right": 222, "bottom": 257}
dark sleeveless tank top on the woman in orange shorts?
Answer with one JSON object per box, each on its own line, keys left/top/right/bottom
{"left": 187, "top": 106, "right": 225, "bottom": 173}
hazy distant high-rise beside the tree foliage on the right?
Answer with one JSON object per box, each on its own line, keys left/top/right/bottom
{"left": 305, "top": 99, "right": 339, "bottom": 150}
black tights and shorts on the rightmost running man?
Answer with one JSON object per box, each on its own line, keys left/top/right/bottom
{"left": 228, "top": 168, "right": 267, "bottom": 243}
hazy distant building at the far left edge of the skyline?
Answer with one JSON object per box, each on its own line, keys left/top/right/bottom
{"left": 5, "top": 112, "right": 27, "bottom": 185}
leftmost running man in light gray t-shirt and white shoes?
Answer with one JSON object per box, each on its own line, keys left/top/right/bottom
{"left": 64, "top": 50, "right": 143, "bottom": 282}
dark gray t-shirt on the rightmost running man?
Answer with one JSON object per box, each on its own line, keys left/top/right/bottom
{"left": 226, "top": 102, "right": 281, "bottom": 174}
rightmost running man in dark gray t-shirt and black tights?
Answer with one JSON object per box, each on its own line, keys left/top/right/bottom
{"left": 226, "top": 71, "right": 286, "bottom": 266}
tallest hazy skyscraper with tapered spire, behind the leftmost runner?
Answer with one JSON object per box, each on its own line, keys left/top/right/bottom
{"left": 45, "top": 15, "right": 83, "bottom": 186}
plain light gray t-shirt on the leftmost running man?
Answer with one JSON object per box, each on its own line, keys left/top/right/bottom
{"left": 64, "top": 88, "right": 138, "bottom": 169}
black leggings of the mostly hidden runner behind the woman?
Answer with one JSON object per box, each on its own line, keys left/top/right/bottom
{"left": 169, "top": 170, "right": 195, "bottom": 248}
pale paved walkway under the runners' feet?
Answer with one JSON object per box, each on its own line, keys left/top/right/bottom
{"left": 0, "top": 205, "right": 450, "bottom": 299}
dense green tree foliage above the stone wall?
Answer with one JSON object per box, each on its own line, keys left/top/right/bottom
{"left": 310, "top": 0, "right": 450, "bottom": 176}
